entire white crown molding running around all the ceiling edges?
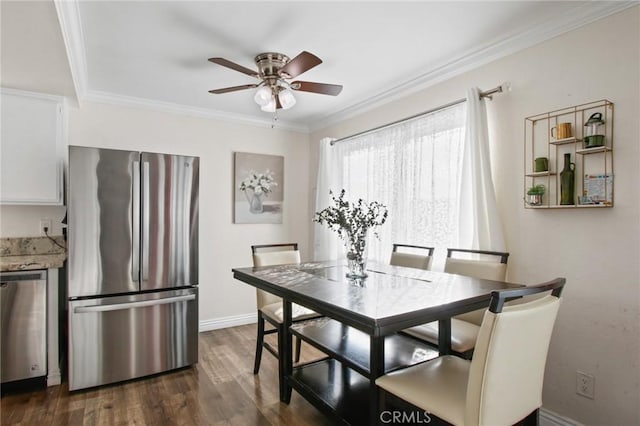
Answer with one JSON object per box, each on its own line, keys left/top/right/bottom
{"left": 54, "top": 0, "right": 640, "bottom": 133}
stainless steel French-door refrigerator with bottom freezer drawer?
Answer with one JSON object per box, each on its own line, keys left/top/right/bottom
{"left": 67, "top": 146, "right": 199, "bottom": 390}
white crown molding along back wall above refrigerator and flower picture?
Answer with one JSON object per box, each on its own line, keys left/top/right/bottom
{"left": 84, "top": 90, "right": 309, "bottom": 134}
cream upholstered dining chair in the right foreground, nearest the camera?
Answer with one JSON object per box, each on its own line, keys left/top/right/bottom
{"left": 376, "top": 278, "right": 565, "bottom": 426}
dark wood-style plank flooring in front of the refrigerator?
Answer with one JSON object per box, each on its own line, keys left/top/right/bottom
{"left": 0, "top": 325, "right": 331, "bottom": 426}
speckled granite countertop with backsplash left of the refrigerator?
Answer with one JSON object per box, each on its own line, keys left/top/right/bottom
{"left": 0, "top": 235, "right": 67, "bottom": 272}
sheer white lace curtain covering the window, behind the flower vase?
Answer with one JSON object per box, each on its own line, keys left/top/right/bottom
{"left": 314, "top": 104, "right": 466, "bottom": 268}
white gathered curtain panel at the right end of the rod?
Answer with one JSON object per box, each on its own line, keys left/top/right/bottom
{"left": 458, "top": 88, "right": 505, "bottom": 251}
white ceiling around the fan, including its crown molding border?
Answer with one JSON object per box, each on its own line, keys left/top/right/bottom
{"left": 2, "top": 1, "right": 637, "bottom": 130}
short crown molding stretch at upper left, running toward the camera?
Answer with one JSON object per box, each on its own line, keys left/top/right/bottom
{"left": 53, "top": 0, "right": 88, "bottom": 105}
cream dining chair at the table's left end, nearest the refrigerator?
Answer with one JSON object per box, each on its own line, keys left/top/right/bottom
{"left": 251, "top": 243, "right": 319, "bottom": 374}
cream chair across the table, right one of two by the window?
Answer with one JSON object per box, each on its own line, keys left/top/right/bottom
{"left": 403, "top": 248, "right": 509, "bottom": 358}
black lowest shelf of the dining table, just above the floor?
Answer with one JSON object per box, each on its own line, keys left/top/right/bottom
{"left": 289, "top": 358, "right": 370, "bottom": 425}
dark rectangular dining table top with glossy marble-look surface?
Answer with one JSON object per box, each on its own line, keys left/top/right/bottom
{"left": 233, "top": 262, "right": 521, "bottom": 335}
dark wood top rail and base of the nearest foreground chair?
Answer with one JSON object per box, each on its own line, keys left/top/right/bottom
{"left": 378, "top": 278, "right": 566, "bottom": 426}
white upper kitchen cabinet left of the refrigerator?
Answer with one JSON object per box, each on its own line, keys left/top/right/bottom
{"left": 0, "top": 88, "right": 65, "bottom": 205}
